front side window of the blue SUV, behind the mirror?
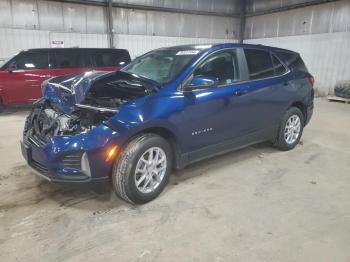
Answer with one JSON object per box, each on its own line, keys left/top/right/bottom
{"left": 194, "top": 50, "right": 239, "bottom": 85}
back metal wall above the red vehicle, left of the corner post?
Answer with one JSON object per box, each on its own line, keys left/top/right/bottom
{"left": 0, "top": 0, "right": 239, "bottom": 60}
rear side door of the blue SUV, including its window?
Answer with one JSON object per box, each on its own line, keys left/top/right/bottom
{"left": 242, "top": 48, "right": 293, "bottom": 133}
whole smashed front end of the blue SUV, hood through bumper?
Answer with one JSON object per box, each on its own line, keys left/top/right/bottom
{"left": 21, "top": 72, "right": 159, "bottom": 182}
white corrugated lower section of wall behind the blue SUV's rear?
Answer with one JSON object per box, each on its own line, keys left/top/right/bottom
{"left": 245, "top": 32, "right": 350, "bottom": 96}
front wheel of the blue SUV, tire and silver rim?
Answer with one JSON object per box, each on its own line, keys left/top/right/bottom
{"left": 112, "top": 134, "right": 172, "bottom": 204}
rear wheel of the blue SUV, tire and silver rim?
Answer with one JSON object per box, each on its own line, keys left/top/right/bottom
{"left": 274, "top": 107, "right": 304, "bottom": 151}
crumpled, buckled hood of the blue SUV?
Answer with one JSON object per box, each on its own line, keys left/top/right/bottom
{"left": 42, "top": 71, "right": 161, "bottom": 114}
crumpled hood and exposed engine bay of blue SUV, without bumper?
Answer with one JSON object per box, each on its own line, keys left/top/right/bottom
{"left": 24, "top": 71, "right": 159, "bottom": 143}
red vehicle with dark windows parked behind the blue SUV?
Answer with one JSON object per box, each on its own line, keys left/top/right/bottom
{"left": 0, "top": 48, "right": 130, "bottom": 110}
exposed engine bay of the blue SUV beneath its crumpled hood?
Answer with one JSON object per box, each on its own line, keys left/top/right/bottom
{"left": 24, "top": 72, "right": 158, "bottom": 143}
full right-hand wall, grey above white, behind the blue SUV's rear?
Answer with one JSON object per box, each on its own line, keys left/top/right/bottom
{"left": 244, "top": 0, "right": 350, "bottom": 95}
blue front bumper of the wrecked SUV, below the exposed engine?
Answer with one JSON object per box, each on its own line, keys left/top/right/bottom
{"left": 21, "top": 125, "right": 118, "bottom": 183}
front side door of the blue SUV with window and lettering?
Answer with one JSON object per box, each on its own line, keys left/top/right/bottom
{"left": 182, "top": 49, "right": 244, "bottom": 151}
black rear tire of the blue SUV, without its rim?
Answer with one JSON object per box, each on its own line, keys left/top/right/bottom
{"left": 274, "top": 107, "right": 305, "bottom": 151}
